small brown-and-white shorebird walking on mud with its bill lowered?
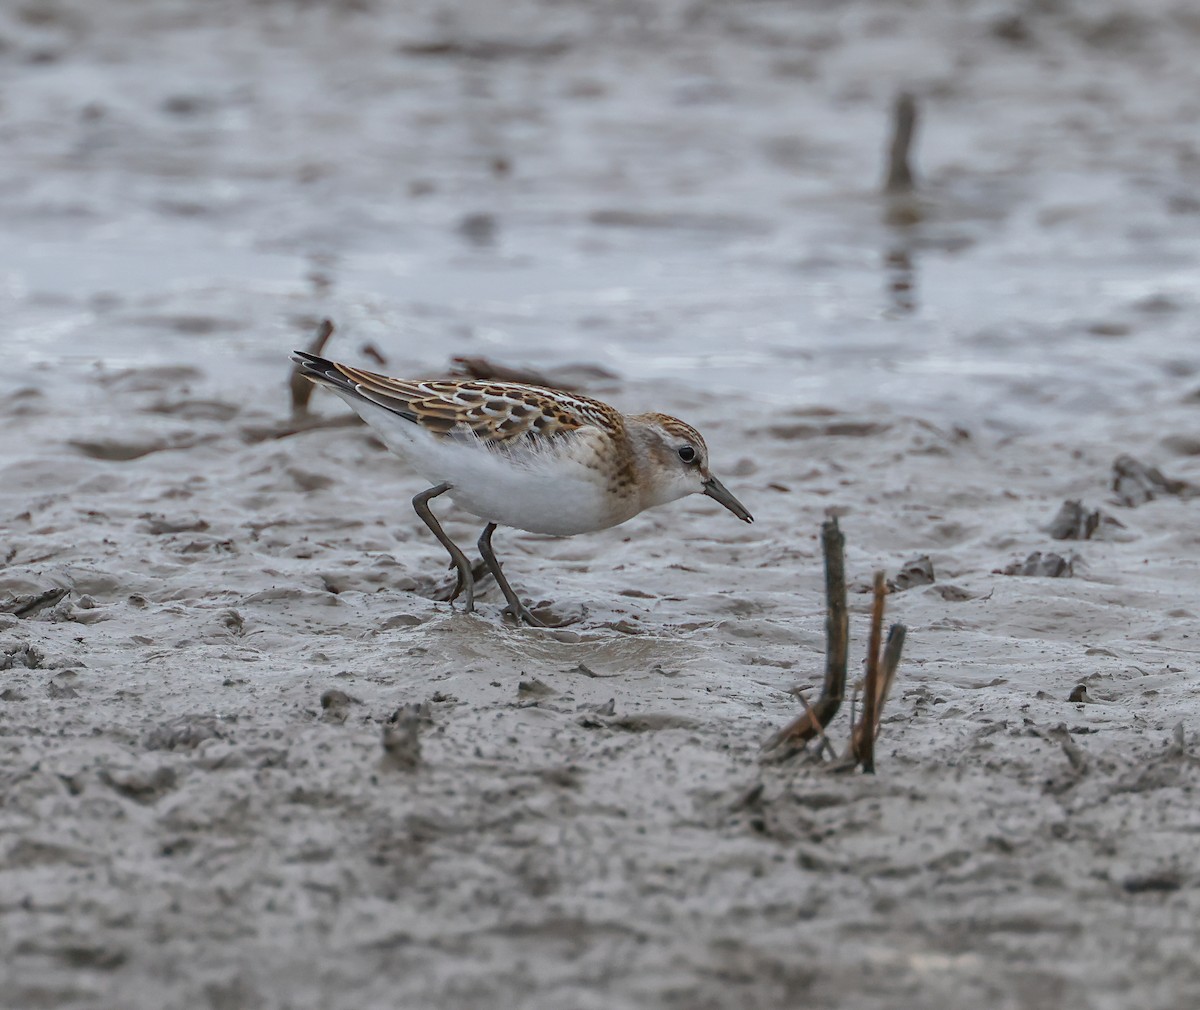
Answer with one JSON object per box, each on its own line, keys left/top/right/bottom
{"left": 292, "top": 350, "right": 754, "bottom": 625}
